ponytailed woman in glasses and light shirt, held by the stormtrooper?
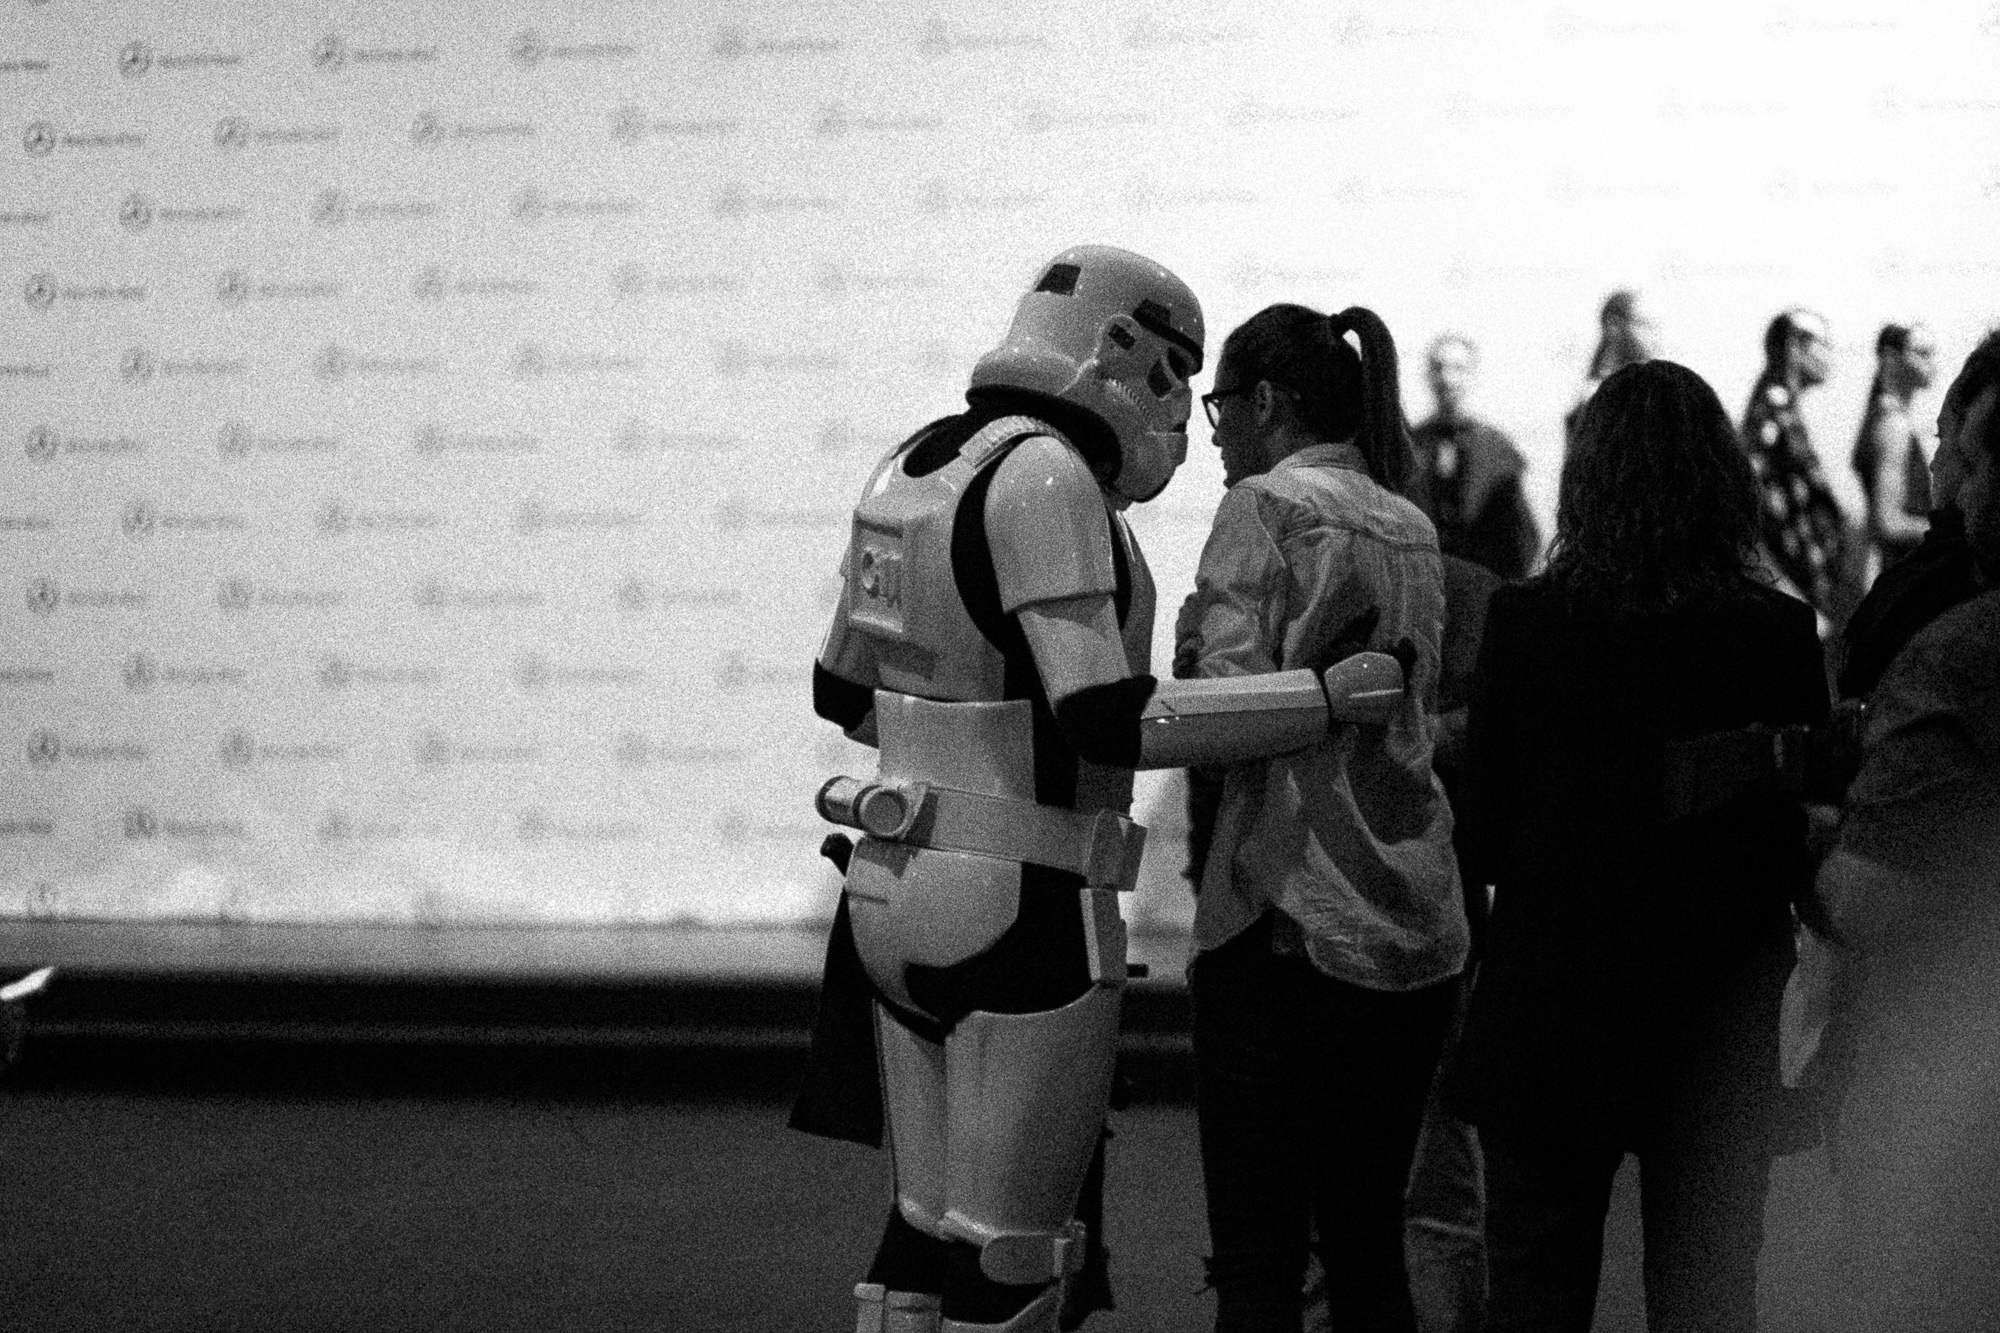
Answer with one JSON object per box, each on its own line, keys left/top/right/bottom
{"left": 1174, "top": 304, "right": 1468, "bottom": 1333}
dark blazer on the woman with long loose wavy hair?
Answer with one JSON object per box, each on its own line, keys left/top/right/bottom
{"left": 1446, "top": 578, "right": 1828, "bottom": 1143}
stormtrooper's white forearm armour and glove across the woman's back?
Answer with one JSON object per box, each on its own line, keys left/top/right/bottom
{"left": 1138, "top": 652, "right": 1404, "bottom": 769}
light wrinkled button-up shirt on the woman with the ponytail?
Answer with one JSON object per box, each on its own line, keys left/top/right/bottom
{"left": 1174, "top": 444, "right": 1468, "bottom": 991}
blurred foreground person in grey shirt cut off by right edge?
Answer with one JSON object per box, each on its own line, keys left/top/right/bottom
{"left": 1814, "top": 336, "right": 2000, "bottom": 1333}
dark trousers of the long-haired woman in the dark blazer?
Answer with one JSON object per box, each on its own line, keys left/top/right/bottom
{"left": 1480, "top": 1127, "right": 1770, "bottom": 1333}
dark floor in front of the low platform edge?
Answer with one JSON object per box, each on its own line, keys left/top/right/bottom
{"left": 0, "top": 1043, "right": 1828, "bottom": 1333}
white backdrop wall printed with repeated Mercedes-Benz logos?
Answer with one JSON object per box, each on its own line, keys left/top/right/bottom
{"left": 0, "top": 0, "right": 2000, "bottom": 925}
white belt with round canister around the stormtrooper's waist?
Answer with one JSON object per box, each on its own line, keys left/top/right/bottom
{"left": 816, "top": 777, "right": 1146, "bottom": 893}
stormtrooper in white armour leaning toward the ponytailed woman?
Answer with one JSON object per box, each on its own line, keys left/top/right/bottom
{"left": 814, "top": 246, "right": 1404, "bottom": 1333}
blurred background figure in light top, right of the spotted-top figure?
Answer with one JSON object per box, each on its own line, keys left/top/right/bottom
{"left": 1852, "top": 324, "right": 1938, "bottom": 568}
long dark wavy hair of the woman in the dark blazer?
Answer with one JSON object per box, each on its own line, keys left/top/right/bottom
{"left": 1542, "top": 360, "right": 1758, "bottom": 614}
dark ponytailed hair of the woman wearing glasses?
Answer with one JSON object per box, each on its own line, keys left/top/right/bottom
{"left": 1222, "top": 304, "right": 1410, "bottom": 492}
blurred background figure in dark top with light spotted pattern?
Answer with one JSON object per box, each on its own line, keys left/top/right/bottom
{"left": 1742, "top": 308, "right": 1862, "bottom": 630}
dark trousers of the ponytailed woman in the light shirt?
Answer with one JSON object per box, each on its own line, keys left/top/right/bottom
{"left": 1190, "top": 917, "right": 1456, "bottom": 1333}
